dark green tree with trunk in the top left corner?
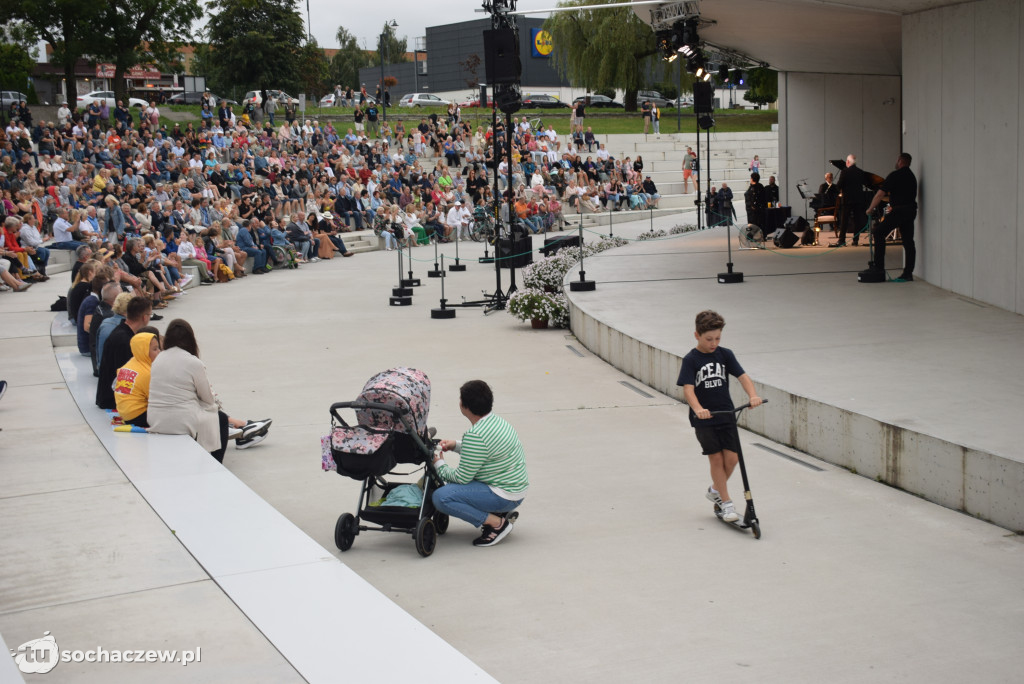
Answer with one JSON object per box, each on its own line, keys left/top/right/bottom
{"left": 0, "top": 0, "right": 104, "bottom": 105}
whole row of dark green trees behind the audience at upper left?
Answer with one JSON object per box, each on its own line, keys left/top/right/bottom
{"left": 0, "top": 0, "right": 407, "bottom": 102}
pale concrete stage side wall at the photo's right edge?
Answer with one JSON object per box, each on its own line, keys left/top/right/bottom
{"left": 903, "top": 0, "right": 1024, "bottom": 313}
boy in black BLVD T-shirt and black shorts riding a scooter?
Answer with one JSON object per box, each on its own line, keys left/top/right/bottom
{"left": 676, "top": 310, "right": 762, "bottom": 522}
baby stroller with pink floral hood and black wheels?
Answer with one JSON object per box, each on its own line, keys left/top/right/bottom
{"left": 323, "top": 368, "right": 449, "bottom": 557}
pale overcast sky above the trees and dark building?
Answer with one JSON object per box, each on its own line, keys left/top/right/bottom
{"left": 299, "top": 0, "right": 557, "bottom": 50}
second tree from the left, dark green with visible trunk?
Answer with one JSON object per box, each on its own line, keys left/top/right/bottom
{"left": 91, "top": 0, "right": 203, "bottom": 100}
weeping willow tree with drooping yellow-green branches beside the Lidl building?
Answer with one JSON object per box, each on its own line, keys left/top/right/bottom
{"left": 544, "top": 0, "right": 657, "bottom": 112}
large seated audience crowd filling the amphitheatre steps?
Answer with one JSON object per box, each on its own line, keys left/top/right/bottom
{"left": 0, "top": 97, "right": 659, "bottom": 290}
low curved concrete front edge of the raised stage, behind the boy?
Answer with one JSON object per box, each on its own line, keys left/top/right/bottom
{"left": 569, "top": 299, "right": 1024, "bottom": 530}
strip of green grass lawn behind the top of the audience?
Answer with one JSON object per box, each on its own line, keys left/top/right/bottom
{"left": 155, "top": 104, "right": 778, "bottom": 135}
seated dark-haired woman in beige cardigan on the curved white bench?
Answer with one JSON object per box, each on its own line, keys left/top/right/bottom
{"left": 147, "top": 318, "right": 270, "bottom": 463}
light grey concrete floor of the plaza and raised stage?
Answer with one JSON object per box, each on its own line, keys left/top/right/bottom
{"left": 0, "top": 210, "right": 1024, "bottom": 684}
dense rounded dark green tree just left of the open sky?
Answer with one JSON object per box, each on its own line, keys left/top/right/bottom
{"left": 207, "top": 0, "right": 306, "bottom": 96}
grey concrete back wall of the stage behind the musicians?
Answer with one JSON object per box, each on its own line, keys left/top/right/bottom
{"left": 778, "top": 72, "right": 900, "bottom": 206}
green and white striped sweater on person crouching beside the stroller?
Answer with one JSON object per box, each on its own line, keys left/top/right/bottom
{"left": 437, "top": 414, "right": 529, "bottom": 500}
